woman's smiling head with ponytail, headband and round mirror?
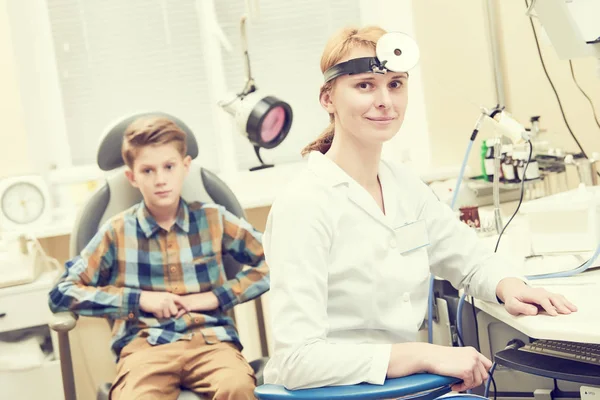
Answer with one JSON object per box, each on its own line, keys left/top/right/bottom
{"left": 302, "top": 27, "right": 419, "bottom": 155}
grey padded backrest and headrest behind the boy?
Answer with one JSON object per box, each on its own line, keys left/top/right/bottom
{"left": 70, "top": 112, "right": 244, "bottom": 279}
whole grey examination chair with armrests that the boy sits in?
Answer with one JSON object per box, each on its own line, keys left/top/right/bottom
{"left": 50, "top": 112, "right": 267, "bottom": 400}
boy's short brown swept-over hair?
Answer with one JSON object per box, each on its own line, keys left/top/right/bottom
{"left": 121, "top": 117, "right": 187, "bottom": 168}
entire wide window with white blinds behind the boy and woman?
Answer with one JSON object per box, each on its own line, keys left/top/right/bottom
{"left": 7, "top": 0, "right": 428, "bottom": 179}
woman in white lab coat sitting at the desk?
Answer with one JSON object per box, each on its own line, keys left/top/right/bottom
{"left": 264, "top": 27, "right": 576, "bottom": 391}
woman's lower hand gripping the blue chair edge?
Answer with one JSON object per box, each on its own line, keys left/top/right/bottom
{"left": 423, "top": 345, "right": 492, "bottom": 392}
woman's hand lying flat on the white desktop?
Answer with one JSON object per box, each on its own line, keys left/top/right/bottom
{"left": 496, "top": 278, "right": 577, "bottom": 316}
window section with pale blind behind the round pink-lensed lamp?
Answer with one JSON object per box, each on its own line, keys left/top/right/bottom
{"left": 215, "top": 0, "right": 361, "bottom": 169}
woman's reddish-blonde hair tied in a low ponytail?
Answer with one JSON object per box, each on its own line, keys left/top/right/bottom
{"left": 302, "top": 26, "right": 387, "bottom": 156}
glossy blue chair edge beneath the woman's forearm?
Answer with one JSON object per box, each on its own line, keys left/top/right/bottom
{"left": 254, "top": 374, "right": 460, "bottom": 400}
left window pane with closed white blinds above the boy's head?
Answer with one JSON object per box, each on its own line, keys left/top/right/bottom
{"left": 47, "top": 0, "right": 218, "bottom": 170}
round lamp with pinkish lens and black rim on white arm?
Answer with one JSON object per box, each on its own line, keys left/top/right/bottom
{"left": 219, "top": 16, "right": 293, "bottom": 171}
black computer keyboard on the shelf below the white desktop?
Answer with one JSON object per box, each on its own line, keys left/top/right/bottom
{"left": 519, "top": 340, "right": 600, "bottom": 366}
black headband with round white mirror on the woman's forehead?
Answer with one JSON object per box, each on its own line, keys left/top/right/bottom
{"left": 324, "top": 32, "right": 419, "bottom": 83}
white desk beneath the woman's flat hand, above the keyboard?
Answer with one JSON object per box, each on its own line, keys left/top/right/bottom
{"left": 475, "top": 255, "right": 600, "bottom": 399}
